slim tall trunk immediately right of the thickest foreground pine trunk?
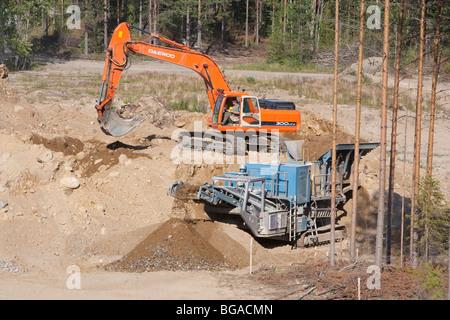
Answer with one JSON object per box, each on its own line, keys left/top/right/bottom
{"left": 386, "top": 0, "right": 405, "bottom": 264}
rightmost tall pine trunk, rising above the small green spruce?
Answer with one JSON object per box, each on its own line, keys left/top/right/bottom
{"left": 427, "top": 0, "right": 442, "bottom": 175}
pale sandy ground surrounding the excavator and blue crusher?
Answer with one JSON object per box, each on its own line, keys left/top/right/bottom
{"left": 0, "top": 60, "right": 450, "bottom": 299}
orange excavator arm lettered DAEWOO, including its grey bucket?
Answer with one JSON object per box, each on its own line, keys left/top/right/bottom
{"left": 96, "top": 22, "right": 231, "bottom": 136}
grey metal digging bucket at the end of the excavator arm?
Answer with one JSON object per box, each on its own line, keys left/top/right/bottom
{"left": 99, "top": 109, "right": 146, "bottom": 137}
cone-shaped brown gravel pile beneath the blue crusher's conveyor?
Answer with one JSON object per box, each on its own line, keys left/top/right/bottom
{"left": 105, "top": 218, "right": 238, "bottom": 272}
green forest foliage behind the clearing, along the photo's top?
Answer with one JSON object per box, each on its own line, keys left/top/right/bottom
{"left": 0, "top": 0, "right": 450, "bottom": 73}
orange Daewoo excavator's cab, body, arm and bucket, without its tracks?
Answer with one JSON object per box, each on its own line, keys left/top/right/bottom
{"left": 96, "top": 22, "right": 300, "bottom": 136}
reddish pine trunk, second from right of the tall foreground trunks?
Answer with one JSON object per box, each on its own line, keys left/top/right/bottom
{"left": 410, "top": 0, "right": 426, "bottom": 268}
